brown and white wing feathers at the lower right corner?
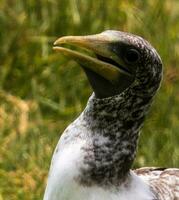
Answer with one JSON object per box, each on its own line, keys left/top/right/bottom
{"left": 134, "top": 167, "right": 179, "bottom": 200}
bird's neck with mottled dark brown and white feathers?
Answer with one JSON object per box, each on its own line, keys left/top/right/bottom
{"left": 80, "top": 87, "right": 155, "bottom": 186}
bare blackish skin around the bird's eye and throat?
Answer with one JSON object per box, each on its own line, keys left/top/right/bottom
{"left": 81, "top": 43, "right": 140, "bottom": 98}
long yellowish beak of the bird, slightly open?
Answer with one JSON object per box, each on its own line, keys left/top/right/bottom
{"left": 53, "top": 32, "right": 130, "bottom": 83}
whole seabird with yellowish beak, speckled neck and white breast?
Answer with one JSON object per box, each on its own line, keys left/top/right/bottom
{"left": 44, "top": 30, "right": 179, "bottom": 200}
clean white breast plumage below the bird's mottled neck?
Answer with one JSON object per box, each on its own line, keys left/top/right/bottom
{"left": 44, "top": 137, "right": 154, "bottom": 200}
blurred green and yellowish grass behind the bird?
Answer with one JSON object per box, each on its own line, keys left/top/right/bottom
{"left": 0, "top": 0, "right": 179, "bottom": 200}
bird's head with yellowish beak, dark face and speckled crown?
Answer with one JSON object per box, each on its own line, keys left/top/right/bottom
{"left": 53, "top": 30, "right": 162, "bottom": 99}
